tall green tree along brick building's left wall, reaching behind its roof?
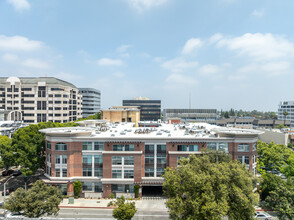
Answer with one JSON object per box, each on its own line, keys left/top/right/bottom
{"left": 12, "top": 122, "right": 77, "bottom": 176}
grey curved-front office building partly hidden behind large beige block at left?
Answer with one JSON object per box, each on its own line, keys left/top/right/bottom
{"left": 79, "top": 88, "right": 101, "bottom": 118}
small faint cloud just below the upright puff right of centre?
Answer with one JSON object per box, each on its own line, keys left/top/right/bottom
{"left": 161, "top": 58, "right": 198, "bottom": 72}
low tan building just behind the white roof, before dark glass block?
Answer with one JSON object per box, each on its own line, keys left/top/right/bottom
{"left": 102, "top": 106, "right": 140, "bottom": 127}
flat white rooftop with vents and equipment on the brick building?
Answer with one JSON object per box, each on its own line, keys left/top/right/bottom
{"left": 40, "top": 122, "right": 263, "bottom": 139}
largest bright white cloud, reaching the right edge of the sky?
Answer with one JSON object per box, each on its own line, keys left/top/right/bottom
{"left": 217, "top": 33, "right": 294, "bottom": 61}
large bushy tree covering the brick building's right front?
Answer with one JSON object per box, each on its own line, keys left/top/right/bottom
{"left": 163, "top": 153, "right": 257, "bottom": 220}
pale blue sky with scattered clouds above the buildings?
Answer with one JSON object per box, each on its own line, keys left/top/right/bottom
{"left": 0, "top": 0, "right": 294, "bottom": 111}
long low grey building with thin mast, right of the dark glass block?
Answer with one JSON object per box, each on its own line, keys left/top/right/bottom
{"left": 163, "top": 109, "right": 217, "bottom": 125}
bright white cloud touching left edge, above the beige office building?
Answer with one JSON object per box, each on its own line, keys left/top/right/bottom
{"left": 0, "top": 35, "right": 44, "bottom": 51}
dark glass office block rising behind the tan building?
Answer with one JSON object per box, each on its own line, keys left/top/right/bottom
{"left": 123, "top": 97, "right": 161, "bottom": 121}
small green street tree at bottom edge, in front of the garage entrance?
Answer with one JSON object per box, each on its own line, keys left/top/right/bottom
{"left": 112, "top": 196, "right": 137, "bottom": 220}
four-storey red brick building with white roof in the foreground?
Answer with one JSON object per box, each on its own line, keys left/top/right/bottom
{"left": 41, "top": 120, "right": 261, "bottom": 198}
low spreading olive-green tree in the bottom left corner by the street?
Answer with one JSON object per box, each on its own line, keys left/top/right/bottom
{"left": 5, "top": 180, "right": 62, "bottom": 218}
